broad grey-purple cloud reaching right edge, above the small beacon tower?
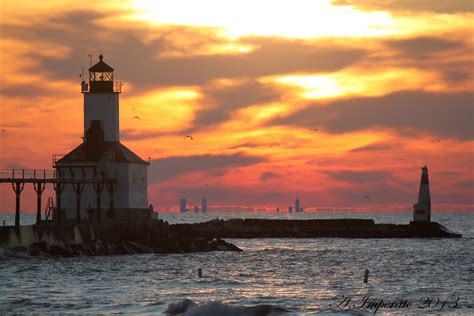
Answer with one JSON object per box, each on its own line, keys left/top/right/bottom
{"left": 272, "top": 91, "right": 474, "bottom": 139}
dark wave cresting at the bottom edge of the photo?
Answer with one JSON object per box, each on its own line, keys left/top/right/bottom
{"left": 165, "top": 299, "right": 291, "bottom": 316}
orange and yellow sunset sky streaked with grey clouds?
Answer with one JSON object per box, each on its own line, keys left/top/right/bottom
{"left": 0, "top": 0, "right": 474, "bottom": 213}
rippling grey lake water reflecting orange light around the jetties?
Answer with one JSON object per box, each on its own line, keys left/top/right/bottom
{"left": 0, "top": 212, "right": 474, "bottom": 315}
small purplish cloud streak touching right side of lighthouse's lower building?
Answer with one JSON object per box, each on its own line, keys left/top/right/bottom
{"left": 149, "top": 154, "right": 264, "bottom": 183}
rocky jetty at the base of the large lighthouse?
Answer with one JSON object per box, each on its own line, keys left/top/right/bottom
{"left": 0, "top": 220, "right": 241, "bottom": 257}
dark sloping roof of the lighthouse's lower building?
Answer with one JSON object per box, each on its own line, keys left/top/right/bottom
{"left": 56, "top": 142, "right": 147, "bottom": 163}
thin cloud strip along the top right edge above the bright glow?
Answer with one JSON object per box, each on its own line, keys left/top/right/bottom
{"left": 332, "top": 0, "right": 474, "bottom": 13}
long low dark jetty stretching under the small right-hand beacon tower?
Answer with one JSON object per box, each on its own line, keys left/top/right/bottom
{"left": 171, "top": 219, "right": 461, "bottom": 238}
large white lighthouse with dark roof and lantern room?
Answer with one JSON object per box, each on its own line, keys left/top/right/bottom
{"left": 53, "top": 55, "right": 150, "bottom": 222}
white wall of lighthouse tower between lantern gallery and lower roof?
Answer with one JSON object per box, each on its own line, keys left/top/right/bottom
{"left": 84, "top": 93, "right": 120, "bottom": 142}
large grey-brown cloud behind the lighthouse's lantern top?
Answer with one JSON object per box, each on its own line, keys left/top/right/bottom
{"left": 2, "top": 11, "right": 365, "bottom": 91}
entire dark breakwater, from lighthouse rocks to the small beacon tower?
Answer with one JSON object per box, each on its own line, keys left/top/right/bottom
{"left": 0, "top": 219, "right": 462, "bottom": 256}
